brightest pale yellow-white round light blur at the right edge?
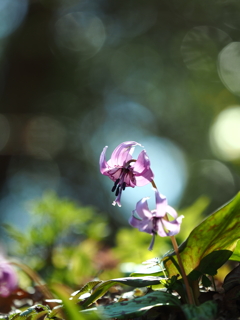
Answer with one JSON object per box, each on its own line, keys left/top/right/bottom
{"left": 210, "top": 106, "right": 240, "bottom": 161}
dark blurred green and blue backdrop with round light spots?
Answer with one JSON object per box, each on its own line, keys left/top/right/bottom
{"left": 0, "top": 0, "right": 240, "bottom": 288}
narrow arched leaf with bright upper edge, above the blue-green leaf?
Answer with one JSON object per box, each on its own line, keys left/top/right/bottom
{"left": 82, "top": 276, "right": 161, "bottom": 307}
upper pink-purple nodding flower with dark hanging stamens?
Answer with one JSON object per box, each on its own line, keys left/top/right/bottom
{"left": 99, "top": 141, "right": 154, "bottom": 207}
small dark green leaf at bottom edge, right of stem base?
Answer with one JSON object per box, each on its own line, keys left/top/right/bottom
{"left": 181, "top": 301, "right": 217, "bottom": 320}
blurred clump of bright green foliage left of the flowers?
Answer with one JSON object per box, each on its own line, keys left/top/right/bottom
{"left": 5, "top": 192, "right": 108, "bottom": 285}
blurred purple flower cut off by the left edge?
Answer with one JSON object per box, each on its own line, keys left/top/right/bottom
{"left": 0, "top": 257, "right": 18, "bottom": 297}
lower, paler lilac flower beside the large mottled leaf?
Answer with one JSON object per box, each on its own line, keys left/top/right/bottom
{"left": 129, "top": 190, "right": 183, "bottom": 250}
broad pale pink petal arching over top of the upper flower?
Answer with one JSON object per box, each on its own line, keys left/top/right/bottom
{"left": 109, "top": 141, "right": 141, "bottom": 167}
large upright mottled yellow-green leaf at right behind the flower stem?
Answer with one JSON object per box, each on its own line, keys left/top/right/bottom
{"left": 164, "top": 193, "right": 240, "bottom": 277}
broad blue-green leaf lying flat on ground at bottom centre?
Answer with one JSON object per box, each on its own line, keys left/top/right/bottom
{"left": 83, "top": 291, "right": 180, "bottom": 319}
